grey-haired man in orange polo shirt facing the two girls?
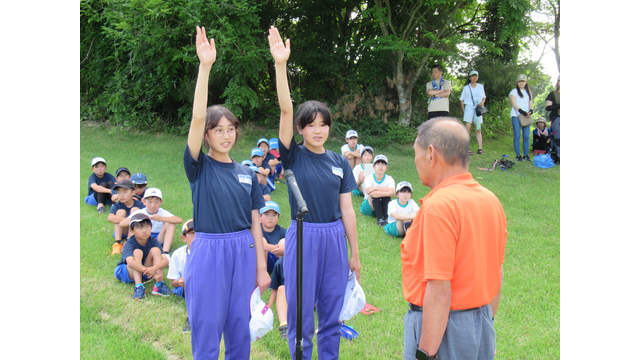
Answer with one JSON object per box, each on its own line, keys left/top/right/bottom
{"left": 401, "top": 118, "right": 507, "bottom": 360}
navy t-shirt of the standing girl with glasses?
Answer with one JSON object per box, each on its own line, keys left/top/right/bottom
{"left": 184, "top": 145, "right": 264, "bottom": 234}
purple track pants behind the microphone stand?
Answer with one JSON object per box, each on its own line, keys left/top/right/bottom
{"left": 282, "top": 220, "right": 349, "bottom": 360}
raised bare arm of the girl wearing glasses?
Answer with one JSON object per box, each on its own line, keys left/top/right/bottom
{"left": 187, "top": 26, "right": 216, "bottom": 160}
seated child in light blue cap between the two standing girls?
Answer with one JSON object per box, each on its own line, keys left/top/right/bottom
{"left": 260, "top": 201, "right": 287, "bottom": 272}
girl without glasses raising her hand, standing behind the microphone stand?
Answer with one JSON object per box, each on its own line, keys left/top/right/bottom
{"left": 269, "top": 27, "right": 361, "bottom": 360}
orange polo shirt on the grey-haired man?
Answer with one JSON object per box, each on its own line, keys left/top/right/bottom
{"left": 400, "top": 173, "right": 507, "bottom": 310}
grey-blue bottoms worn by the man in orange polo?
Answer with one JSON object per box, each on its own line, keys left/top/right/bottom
{"left": 404, "top": 304, "right": 496, "bottom": 360}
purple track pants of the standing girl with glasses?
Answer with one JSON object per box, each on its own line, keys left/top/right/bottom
{"left": 184, "top": 230, "right": 256, "bottom": 360}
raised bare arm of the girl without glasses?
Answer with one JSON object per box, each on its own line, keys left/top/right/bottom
{"left": 269, "top": 26, "right": 293, "bottom": 149}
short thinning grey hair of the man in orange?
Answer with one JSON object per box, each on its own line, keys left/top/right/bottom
{"left": 416, "top": 117, "right": 469, "bottom": 167}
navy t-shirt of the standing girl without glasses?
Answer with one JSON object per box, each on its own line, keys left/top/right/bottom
{"left": 278, "top": 137, "right": 358, "bottom": 223}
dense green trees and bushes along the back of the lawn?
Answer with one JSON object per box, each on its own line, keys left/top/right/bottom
{"left": 80, "top": 0, "right": 550, "bottom": 141}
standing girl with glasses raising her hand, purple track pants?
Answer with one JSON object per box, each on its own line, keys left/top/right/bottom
{"left": 184, "top": 27, "right": 270, "bottom": 359}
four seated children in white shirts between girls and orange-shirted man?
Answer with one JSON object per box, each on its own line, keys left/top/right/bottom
{"left": 342, "top": 130, "right": 420, "bottom": 237}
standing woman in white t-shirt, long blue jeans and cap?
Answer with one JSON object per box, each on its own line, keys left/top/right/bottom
{"left": 509, "top": 74, "right": 533, "bottom": 161}
